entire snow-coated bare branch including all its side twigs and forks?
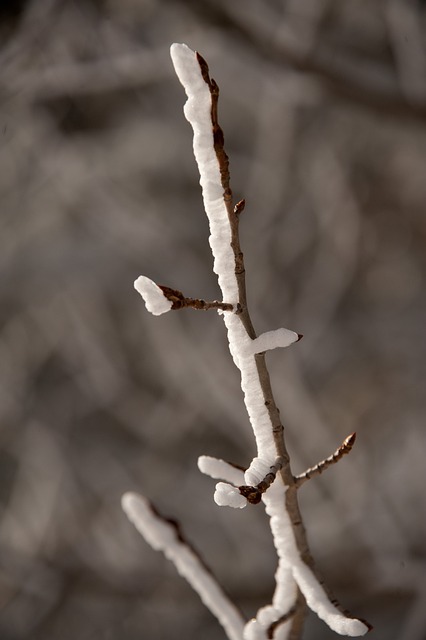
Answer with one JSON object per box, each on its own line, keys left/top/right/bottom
{"left": 123, "top": 44, "right": 369, "bottom": 640}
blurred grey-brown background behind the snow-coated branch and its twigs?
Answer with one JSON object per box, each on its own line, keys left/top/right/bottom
{"left": 0, "top": 0, "right": 426, "bottom": 640}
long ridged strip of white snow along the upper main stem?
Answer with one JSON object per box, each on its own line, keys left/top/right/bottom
{"left": 170, "top": 44, "right": 278, "bottom": 466}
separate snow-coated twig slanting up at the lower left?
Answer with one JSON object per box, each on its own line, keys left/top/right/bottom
{"left": 122, "top": 493, "right": 244, "bottom": 640}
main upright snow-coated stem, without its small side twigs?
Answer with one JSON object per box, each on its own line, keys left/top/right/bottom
{"left": 171, "top": 45, "right": 368, "bottom": 637}
